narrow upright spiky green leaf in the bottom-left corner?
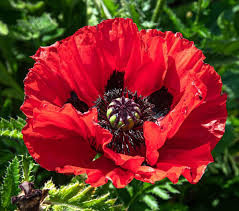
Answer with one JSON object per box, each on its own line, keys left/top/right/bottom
{"left": 0, "top": 157, "right": 20, "bottom": 210}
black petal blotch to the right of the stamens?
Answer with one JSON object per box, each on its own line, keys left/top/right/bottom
{"left": 149, "top": 87, "right": 173, "bottom": 118}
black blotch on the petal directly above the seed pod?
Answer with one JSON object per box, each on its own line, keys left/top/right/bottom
{"left": 105, "top": 70, "right": 124, "bottom": 92}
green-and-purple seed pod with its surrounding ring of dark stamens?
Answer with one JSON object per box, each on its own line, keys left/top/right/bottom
{"left": 96, "top": 89, "right": 156, "bottom": 154}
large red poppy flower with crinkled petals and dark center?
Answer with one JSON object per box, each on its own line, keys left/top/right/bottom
{"left": 21, "top": 18, "right": 227, "bottom": 188}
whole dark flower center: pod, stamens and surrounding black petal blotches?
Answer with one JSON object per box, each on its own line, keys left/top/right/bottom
{"left": 66, "top": 71, "right": 173, "bottom": 155}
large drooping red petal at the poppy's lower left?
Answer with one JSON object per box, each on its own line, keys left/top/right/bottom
{"left": 23, "top": 99, "right": 137, "bottom": 188}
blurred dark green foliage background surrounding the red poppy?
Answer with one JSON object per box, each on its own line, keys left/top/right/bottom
{"left": 0, "top": 0, "right": 239, "bottom": 211}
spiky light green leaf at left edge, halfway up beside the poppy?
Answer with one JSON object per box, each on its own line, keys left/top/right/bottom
{"left": 0, "top": 117, "right": 25, "bottom": 139}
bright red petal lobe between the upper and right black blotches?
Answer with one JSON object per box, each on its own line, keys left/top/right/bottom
{"left": 125, "top": 30, "right": 168, "bottom": 96}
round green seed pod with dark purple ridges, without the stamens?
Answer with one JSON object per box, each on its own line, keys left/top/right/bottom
{"left": 106, "top": 96, "right": 141, "bottom": 130}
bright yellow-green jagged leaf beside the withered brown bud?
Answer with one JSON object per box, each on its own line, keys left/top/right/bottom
{"left": 44, "top": 180, "right": 121, "bottom": 211}
